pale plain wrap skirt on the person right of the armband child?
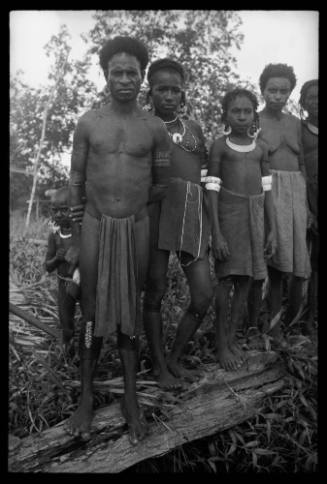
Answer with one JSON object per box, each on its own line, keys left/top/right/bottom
{"left": 268, "top": 170, "right": 310, "bottom": 278}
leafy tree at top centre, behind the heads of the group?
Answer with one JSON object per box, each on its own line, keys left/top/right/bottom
{"left": 84, "top": 10, "right": 252, "bottom": 139}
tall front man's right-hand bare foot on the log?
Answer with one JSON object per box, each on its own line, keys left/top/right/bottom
{"left": 120, "top": 396, "right": 148, "bottom": 445}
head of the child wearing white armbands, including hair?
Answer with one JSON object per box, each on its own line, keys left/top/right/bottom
{"left": 221, "top": 88, "right": 259, "bottom": 134}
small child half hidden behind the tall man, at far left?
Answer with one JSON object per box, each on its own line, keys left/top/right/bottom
{"left": 45, "top": 187, "right": 79, "bottom": 350}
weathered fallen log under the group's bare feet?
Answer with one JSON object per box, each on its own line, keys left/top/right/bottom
{"left": 8, "top": 350, "right": 285, "bottom": 473}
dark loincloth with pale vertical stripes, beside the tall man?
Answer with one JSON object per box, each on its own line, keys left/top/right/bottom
{"left": 158, "top": 178, "right": 210, "bottom": 259}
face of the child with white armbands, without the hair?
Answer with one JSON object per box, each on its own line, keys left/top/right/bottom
{"left": 226, "top": 96, "right": 254, "bottom": 135}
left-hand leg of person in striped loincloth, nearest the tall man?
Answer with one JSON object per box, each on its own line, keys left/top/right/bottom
{"left": 144, "top": 248, "right": 180, "bottom": 388}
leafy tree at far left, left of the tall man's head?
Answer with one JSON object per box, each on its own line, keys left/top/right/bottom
{"left": 10, "top": 25, "right": 97, "bottom": 214}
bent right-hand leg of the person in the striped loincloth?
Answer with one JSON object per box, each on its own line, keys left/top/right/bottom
{"left": 167, "top": 255, "right": 213, "bottom": 378}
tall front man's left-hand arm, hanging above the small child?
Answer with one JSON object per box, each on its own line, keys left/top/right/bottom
{"left": 65, "top": 114, "right": 89, "bottom": 273}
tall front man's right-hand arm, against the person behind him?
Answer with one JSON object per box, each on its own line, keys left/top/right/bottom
{"left": 149, "top": 117, "right": 171, "bottom": 203}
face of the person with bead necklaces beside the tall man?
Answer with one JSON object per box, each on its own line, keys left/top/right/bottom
{"left": 151, "top": 70, "right": 183, "bottom": 115}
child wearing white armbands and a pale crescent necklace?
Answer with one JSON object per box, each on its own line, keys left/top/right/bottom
{"left": 206, "top": 89, "right": 275, "bottom": 370}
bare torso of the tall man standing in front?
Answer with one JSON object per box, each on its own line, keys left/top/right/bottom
{"left": 85, "top": 107, "right": 158, "bottom": 218}
